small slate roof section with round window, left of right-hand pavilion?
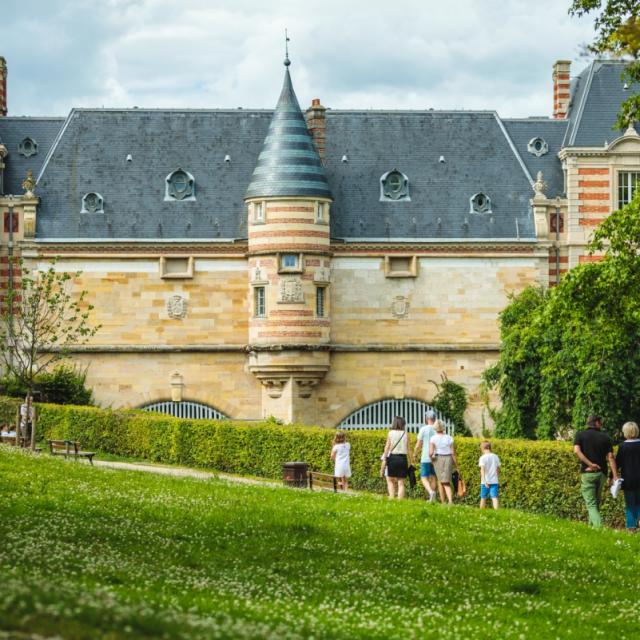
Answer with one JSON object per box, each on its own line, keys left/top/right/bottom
{"left": 503, "top": 118, "right": 568, "bottom": 198}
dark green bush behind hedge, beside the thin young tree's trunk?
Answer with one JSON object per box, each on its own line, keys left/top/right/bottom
{"left": 0, "top": 364, "right": 93, "bottom": 405}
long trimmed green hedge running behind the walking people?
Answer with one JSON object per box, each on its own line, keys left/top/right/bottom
{"left": 31, "top": 404, "right": 623, "bottom": 526}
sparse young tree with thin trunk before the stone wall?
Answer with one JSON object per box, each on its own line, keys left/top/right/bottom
{"left": 0, "top": 261, "right": 100, "bottom": 447}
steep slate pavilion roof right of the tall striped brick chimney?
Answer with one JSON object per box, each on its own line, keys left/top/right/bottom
{"left": 563, "top": 60, "right": 640, "bottom": 147}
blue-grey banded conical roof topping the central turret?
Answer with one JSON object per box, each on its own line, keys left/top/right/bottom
{"left": 245, "top": 58, "right": 331, "bottom": 198}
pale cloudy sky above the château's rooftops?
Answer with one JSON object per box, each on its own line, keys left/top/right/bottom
{"left": 0, "top": 0, "right": 593, "bottom": 117}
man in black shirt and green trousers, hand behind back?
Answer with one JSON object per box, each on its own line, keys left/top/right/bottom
{"left": 573, "top": 416, "right": 618, "bottom": 529}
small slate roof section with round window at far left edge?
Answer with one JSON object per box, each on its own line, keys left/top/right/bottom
{"left": 0, "top": 117, "right": 65, "bottom": 194}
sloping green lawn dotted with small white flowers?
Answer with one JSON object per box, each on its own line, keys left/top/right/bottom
{"left": 0, "top": 447, "right": 640, "bottom": 640}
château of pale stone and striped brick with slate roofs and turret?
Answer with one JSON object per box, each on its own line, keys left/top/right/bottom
{"left": 0, "top": 58, "right": 640, "bottom": 430}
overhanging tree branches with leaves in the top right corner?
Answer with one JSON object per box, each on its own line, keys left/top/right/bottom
{"left": 569, "top": 0, "right": 640, "bottom": 129}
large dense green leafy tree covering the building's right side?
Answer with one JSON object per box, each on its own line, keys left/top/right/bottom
{"left": 484, "top": 191, "right": 640, "bottom": 438}
